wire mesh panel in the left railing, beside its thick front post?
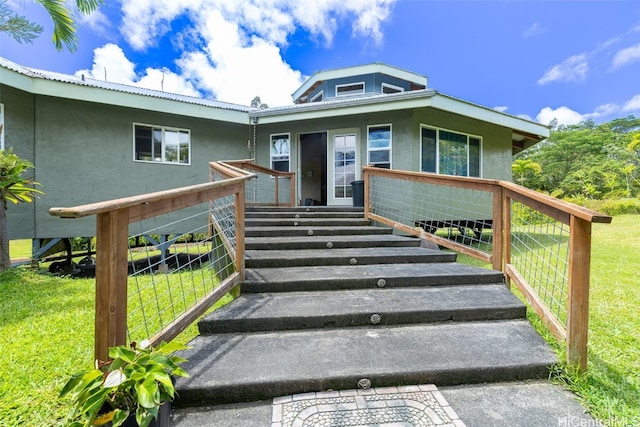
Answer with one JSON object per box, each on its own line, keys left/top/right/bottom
{"left": 127, "top": 202, "right": 235, "bottom": 342}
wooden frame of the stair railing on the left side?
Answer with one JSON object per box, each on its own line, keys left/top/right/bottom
{"left": 49, "top": 162, "right": 255, "bottom": 360}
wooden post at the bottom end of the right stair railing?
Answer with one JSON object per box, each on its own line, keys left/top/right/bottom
{"left": 567, "top": 215, "right": 591, "bottom": 371}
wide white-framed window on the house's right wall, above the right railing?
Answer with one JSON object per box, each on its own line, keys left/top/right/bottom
{"left": 420, "top": 126, "right": 482, "bottom": 177}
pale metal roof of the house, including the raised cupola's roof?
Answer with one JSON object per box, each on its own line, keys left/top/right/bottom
{"left": 0, "top": 57, "right": 549, "bottom": 146}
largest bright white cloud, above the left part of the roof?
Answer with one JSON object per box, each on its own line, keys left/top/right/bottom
{"left": 107, "top": 0, "right": 396, "bottom": 106}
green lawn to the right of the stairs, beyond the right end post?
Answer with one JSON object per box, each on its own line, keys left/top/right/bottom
{"left": 458, "top": 215, "right": 640, "bottom": 427}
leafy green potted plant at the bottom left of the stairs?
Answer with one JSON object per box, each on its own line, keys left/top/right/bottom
{"left": 60, "top": 341, "right": 189, "bottom": 427}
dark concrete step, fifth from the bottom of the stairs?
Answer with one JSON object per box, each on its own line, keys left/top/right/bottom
{"left": 245, "top": 234, "right": 420, "bottom": 250}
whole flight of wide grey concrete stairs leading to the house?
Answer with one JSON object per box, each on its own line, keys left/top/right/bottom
{"left": 176, "top": 207, "right": 556, "bottom": 406}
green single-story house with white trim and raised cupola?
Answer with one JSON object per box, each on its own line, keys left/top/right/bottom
{"left": 0, "top": 58, "right": 549, "bottom": 247}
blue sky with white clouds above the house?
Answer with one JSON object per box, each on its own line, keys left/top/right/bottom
{"left": 0, "top": 0, "right": 640, "bottom": 124}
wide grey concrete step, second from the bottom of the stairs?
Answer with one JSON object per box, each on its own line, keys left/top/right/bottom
{"left": 198, "top": 283, "right": 526, "bottom": 335}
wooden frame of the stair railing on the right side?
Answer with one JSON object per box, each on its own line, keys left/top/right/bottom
{"left": 363, "top": 166, "right": 611, "bottom": 370}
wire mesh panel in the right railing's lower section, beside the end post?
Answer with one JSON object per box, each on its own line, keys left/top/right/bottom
{"left": 511, "top": 201, "right": 570, "bottom": 325}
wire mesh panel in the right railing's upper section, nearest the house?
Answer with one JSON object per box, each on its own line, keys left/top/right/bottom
{"left": 369, "top": 175, "right": 493, "bottom": 254}
